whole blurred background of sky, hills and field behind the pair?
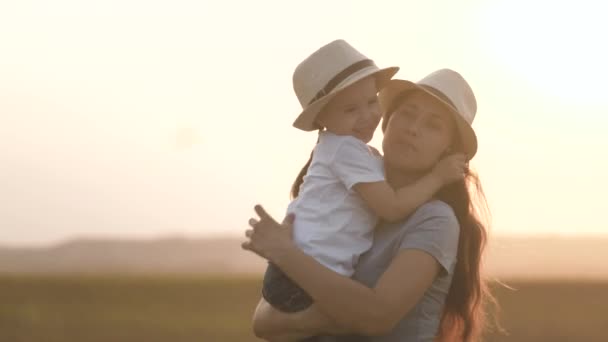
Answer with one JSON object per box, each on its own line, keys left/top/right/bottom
{"left": 0, "top": 0, "right": 608, "bottom": 341}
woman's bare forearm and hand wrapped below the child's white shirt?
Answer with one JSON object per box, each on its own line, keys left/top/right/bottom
{"left": 243, "top": 206, "right": 441, "bottom": 335}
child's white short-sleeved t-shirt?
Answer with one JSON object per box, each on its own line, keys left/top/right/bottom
{"left": 287, "top": 132, "right": 384, "bottom": 276}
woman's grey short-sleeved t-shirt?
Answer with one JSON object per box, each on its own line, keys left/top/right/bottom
{"left": 323, "top": 200, "right": 460, "bottom": 342}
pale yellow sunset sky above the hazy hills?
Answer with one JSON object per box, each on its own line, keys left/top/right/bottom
{"left": 0, "top": 0, "right": 608, "bottom": 245}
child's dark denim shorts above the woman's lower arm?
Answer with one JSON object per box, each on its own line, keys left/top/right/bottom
{"left": 262, "top": 263, "right": 313, "bottom": 312}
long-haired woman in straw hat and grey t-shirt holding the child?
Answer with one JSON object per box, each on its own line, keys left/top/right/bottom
{"left": 243, "top": 69, "right": 489, "bottom": 341}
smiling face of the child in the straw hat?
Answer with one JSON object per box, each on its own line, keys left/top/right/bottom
{"left": 317, "top": 77, "right": 381, "bottom": 143}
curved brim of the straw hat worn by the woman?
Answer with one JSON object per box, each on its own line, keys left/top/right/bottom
{"left": 378, "top": 80, "right": 477, "bottom": 160}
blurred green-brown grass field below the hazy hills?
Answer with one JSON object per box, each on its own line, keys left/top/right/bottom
{"left": 0, "top": 275, "right": 608, "bottom": 342}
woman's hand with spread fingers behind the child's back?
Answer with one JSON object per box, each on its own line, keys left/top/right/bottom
{"left": 241, "top": 204, "right": 296, "bottom": 261}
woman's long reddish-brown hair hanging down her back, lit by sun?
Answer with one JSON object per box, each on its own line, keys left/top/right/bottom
{"left": 382, "top": 92, "right": 499, "bottom": 342}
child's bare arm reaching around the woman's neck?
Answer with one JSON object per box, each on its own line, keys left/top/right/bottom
{"left": 353, "top": 155, "right": 465, "bottom": 222}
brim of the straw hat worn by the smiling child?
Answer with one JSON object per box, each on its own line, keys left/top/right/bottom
{"left": 293, "top": 67, "right": 399, "bottom": 131}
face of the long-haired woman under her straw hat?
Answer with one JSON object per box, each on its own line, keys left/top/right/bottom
{"left": 382, "top": 91, "right": 455, "bottom": 172}
